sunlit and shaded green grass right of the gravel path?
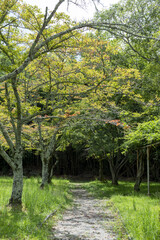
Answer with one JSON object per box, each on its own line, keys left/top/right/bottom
{"left": 84, "top": 181, "right": 160, "bottom": 240}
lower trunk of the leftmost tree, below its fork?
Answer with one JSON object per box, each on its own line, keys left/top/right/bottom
{"left": 9, "top": 153, "right": 23, "bottom": 205}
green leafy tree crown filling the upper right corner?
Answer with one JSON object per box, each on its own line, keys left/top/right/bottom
{"left": 96, "top": 0, "right": 160, "bottom": 114}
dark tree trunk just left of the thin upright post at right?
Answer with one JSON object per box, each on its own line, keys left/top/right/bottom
{"left": 134, "top": 150, "right": 144, "bottom": 192}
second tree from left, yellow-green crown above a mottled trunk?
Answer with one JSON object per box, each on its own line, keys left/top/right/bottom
{"left": 23, "top": 37, "right": 106, "bottom": 186}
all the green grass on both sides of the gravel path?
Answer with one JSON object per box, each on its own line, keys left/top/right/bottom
{"left": 0, "top": 177, "right": 160, "bottom": 240}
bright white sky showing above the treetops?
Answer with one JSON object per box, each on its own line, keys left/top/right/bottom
{"left": 24, "top": 0, "right": 119, "bottom": 21}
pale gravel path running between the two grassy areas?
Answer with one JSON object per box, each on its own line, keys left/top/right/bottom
{"left": 52, "top": 185, "right": 117, "bottom": 240}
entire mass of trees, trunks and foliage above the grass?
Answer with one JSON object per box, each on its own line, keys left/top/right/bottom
{"left": 0, "top": 0, "right": 160, "bottom": 204}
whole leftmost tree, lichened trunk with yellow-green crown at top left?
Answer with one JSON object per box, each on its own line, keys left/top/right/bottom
{"left": 0, "top": 0, "right": 102, "bottom": 205}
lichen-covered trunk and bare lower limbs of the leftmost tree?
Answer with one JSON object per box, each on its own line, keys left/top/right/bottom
{"left": 0, "top": 79, "right": 23, "bottom": 204}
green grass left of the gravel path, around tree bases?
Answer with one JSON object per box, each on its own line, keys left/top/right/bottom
{"left": 0, "top": 177, "right": 72, "bottom": 240}
